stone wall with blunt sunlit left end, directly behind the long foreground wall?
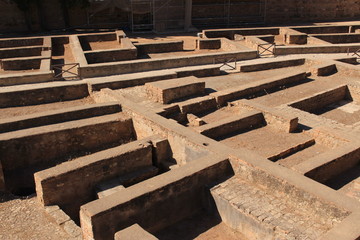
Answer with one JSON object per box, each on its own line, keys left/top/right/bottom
{"left": 34, "top": 138, "right": 162, "bottom": 219}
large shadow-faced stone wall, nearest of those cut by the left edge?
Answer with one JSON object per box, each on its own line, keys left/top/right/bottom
{"left": 0, "top": 114, "right": 135, "bottom": 191}
